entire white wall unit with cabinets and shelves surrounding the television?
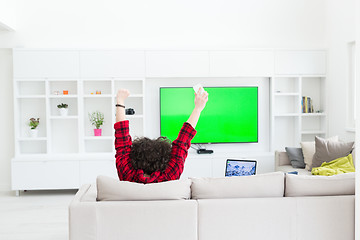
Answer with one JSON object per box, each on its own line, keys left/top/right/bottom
{"left": 11, "top": 49, "right": 327, "bottom": 190}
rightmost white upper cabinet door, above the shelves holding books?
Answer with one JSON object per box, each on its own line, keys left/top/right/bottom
{"left": 275, "top": 50, "right": 326, "bottom": 75}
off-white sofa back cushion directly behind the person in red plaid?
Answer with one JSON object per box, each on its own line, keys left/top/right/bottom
{"left": 96, "top": 176, "right": 191, "bottom": 201}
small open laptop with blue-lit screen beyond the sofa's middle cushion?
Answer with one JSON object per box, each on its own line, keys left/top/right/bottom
{"left": 225, "top": 159, "right": 256, "bottom": 177}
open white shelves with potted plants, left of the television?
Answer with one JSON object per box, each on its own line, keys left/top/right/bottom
{"left": 15, "top": 78, "right": 144, "bottom": 155}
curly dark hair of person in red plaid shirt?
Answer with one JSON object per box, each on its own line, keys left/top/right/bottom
{"left": 130, "top": 137, "right": 172, "bottom": 175}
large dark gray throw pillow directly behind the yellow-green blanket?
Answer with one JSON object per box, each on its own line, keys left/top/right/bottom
{"left": 312, "top": 137, "right": 354, "bottom": 168}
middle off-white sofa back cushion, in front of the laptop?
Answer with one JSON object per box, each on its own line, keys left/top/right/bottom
{"left": 191, "top": 172, "right": 284, "bottom": 199}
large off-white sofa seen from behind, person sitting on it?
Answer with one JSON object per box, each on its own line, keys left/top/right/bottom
{"left": 69, "top": 172, "right": 355, "bottom": 240}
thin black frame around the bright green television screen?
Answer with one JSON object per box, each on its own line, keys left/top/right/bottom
{"left": 159, "top": 86, "right": 259, "bottom": 144}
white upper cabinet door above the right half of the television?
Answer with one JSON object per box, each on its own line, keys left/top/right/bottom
{"left": 210, "top": 50, "right": 274, "bottom": 77}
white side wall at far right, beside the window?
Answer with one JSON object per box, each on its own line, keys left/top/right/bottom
{"left": 327, "top": 0, "right": 356, "bottom": 141}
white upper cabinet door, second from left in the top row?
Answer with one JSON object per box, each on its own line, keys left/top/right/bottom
{"left": 80, "top": 50, "right": 145, "bottom": 78}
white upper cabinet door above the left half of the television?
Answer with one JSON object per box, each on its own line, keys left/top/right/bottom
{"left": 146, "top": 51, "right": 209, "bottom": 77}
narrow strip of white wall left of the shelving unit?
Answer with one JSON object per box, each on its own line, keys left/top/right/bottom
{"left": 0, "top": 49, "right": 14, "bottom": 190}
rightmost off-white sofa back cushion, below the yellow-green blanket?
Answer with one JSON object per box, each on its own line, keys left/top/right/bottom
{"left": 285, "top": 173, "right": 355, "bottom": 197}
